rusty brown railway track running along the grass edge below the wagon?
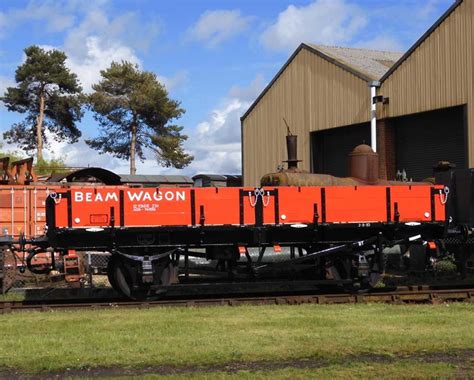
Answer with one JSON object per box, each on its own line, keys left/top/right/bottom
{"left": 0, "top": 287, "right": 474, "bottom": 314}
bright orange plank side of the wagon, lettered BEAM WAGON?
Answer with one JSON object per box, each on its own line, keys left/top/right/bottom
{"left": 52, "top": 186, "right": 446, "bottom": 229}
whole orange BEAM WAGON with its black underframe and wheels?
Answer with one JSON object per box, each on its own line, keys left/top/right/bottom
{"left": 39, "top": 184, "right": 447, "bottom": 298}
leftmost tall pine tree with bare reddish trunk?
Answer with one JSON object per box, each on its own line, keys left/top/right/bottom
{"left": 0, "top": 46, "right": 83, "bottom": 161}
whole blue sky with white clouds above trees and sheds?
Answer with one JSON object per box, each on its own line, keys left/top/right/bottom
{"left": 0, "top": 0, "right": 454, "bottom": 176}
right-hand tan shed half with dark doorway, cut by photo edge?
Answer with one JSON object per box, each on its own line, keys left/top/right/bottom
{"left": 377, "top": 0, "right": 474, "bottom": 179}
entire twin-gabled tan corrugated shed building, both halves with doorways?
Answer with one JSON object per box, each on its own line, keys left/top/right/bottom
{"left": 241, "top": 0, "right": 474, "bottom": 186}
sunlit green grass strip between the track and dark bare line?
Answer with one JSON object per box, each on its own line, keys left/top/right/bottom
{"left": 0, "top": 303, "right": 474, "bottom": 378}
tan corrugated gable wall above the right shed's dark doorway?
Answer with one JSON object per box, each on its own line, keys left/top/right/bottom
{"left": 379, "top": 0, "right": 474, "bottom": 167}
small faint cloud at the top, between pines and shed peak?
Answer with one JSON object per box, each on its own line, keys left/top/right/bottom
{"left": 187, "top": 10, "right": 253, "bottom": 47}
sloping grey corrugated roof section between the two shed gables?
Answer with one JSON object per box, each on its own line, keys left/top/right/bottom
{"left": 307, "top": 44, "right": 403, "bottom": 80}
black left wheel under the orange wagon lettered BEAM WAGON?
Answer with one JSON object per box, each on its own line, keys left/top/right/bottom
{"left": 107, "top": 254, "right": 174, "bottom": 300}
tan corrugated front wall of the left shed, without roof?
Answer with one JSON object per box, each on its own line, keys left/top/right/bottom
{"left": 242, "top": 49, "right": 370, "bottom": 186}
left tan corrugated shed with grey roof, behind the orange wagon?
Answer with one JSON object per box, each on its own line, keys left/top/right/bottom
{"left": 241, "top": 43, "right": 402, "bottom": 186}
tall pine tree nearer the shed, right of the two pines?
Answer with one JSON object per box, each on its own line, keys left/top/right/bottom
{"left": 86, "top": 61, "right": 193, "bottom": 174}
